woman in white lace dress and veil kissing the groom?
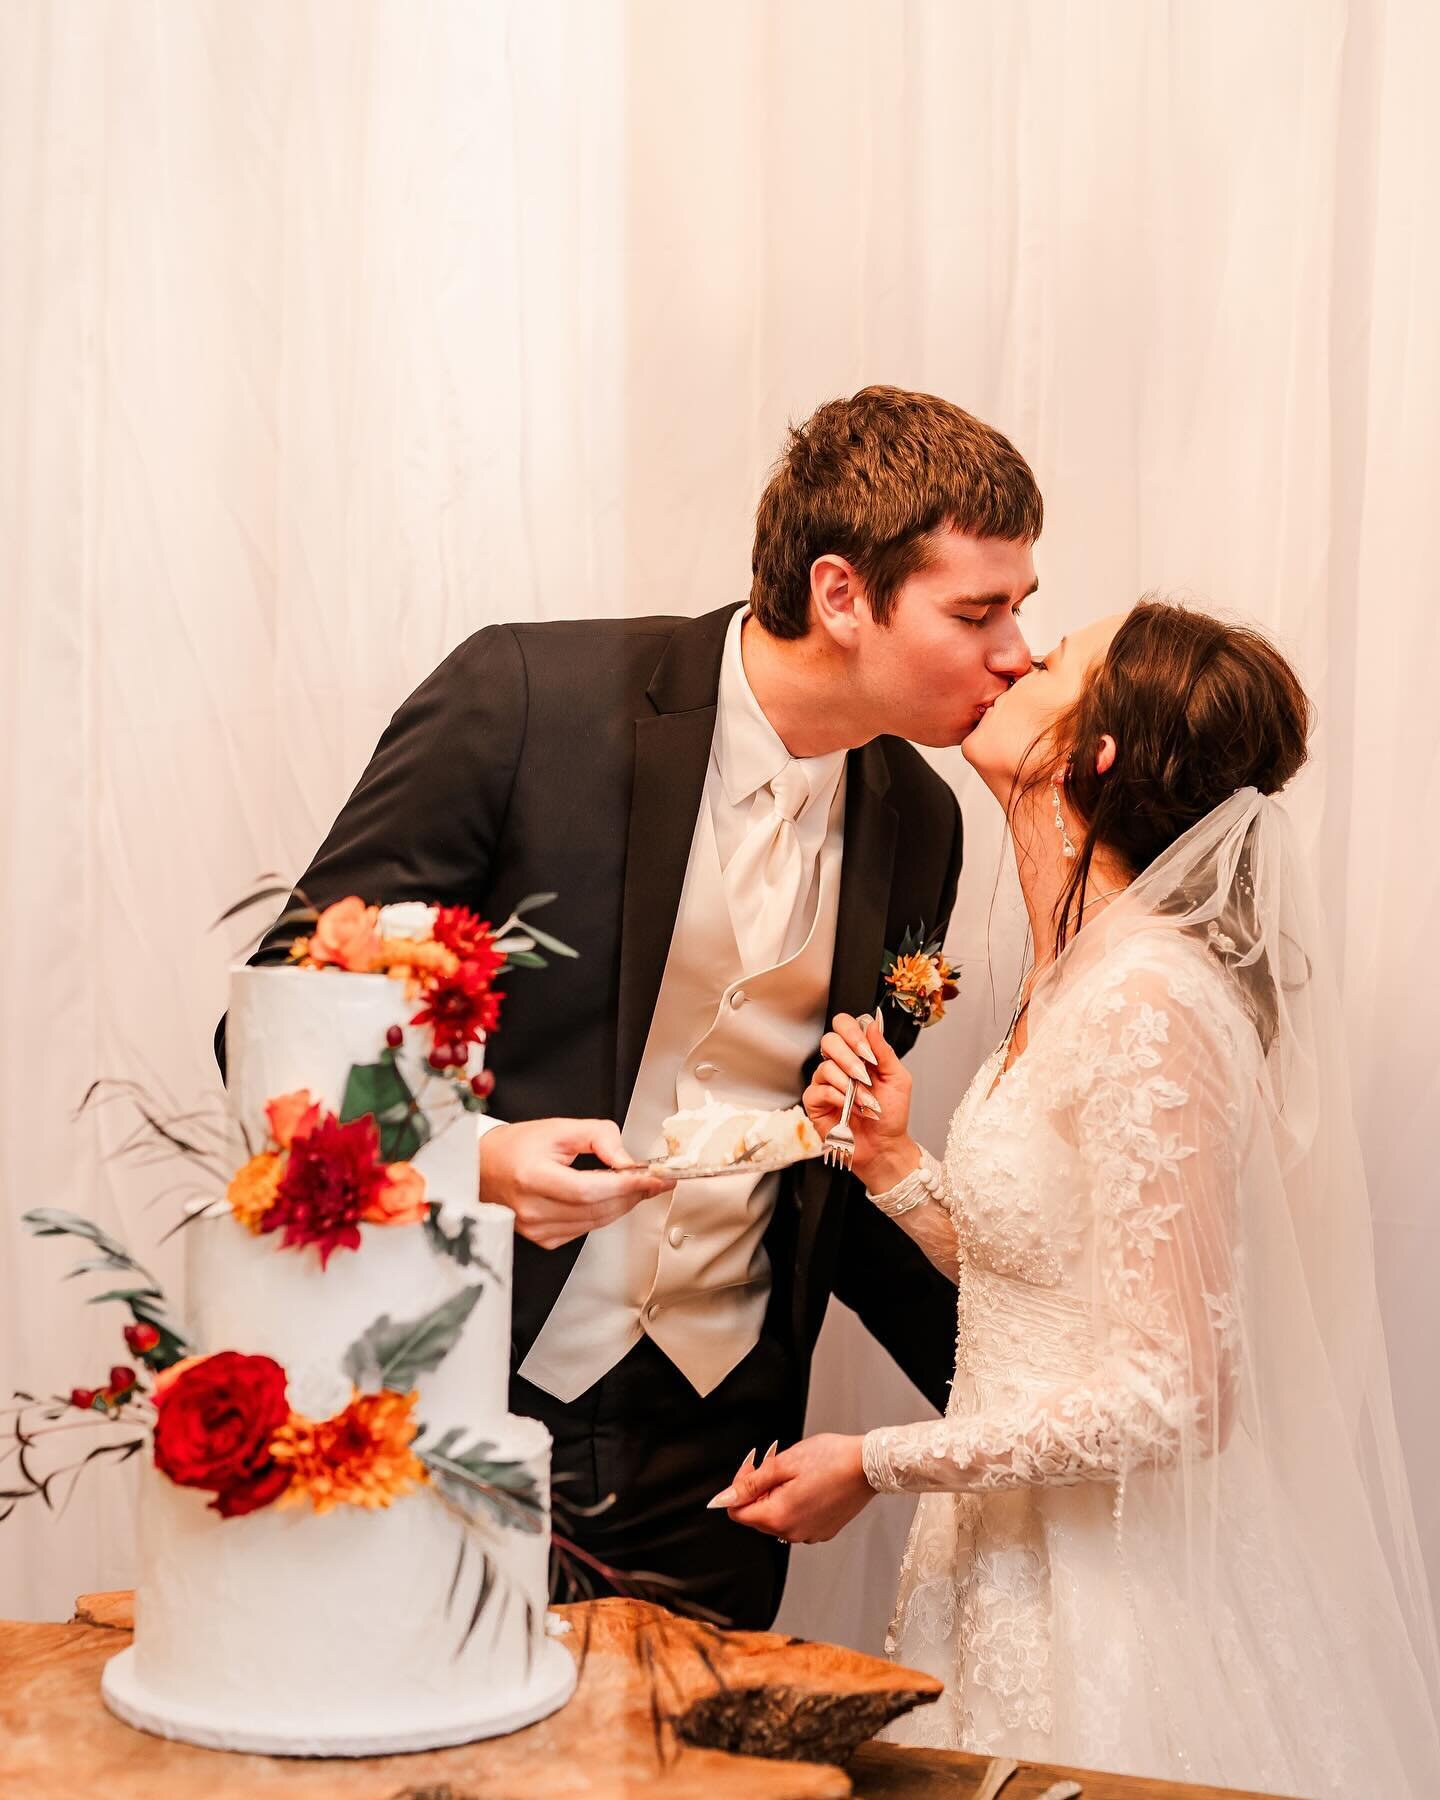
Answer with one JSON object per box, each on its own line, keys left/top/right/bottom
{"left": 715, "top": 603, "right": 1440, "bottom": 1796}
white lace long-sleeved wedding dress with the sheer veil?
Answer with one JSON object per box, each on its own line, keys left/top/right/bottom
{"left": 864, "top": 790, "right": 1440, "bottom": 1796}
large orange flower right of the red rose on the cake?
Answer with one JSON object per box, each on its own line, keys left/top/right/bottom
{"left": 270, "top": 1391, "right": 428, "bottom": 1512}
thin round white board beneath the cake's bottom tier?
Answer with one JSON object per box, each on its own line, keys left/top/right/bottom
{"left": 101, "top": 1638, "right": 576, "bottom": 1757}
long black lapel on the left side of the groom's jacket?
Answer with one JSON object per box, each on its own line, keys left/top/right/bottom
{"left": 616, "top": 607, "right": 736, "bottom": 1120}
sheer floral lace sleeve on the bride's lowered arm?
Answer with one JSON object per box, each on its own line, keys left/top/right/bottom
{"left": 864, "top": 963, "right": 1244, "bottom": 1490}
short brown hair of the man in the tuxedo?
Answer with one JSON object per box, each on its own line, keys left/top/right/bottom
{"left": 751, "top": 387, "right": 1044, "bottom": 637}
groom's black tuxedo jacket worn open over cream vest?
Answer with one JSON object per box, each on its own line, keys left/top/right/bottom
{"left": 239, "top": 607, "right": 961, "bottom": 1429}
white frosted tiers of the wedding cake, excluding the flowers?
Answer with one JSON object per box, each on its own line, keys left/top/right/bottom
{"left": 104, "top": 968, "right": 574, "bottom": 1755}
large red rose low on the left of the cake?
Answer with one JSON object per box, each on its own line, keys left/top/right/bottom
{"left": 155, "top": 1350, "right": 290, "bottom": 1519}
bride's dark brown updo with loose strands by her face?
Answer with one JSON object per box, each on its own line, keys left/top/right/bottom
{"left": 1024, "top": 599, "right": 1312, "bottom": 956}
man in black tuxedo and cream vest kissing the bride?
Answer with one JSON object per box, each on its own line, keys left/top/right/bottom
{"left": 241, "top": 387, "right": 1042, "bottom": 1627}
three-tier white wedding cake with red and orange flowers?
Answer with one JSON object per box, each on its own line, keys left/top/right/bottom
{"left": 94, "top": 902, "right": 574, "bottom": 1755}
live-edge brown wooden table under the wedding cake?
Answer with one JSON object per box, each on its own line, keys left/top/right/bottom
{"left": 0, "top": 1593, "right": 1296, "bottom": 1800}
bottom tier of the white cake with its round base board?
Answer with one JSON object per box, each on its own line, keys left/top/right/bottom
{"left": 104, "top": 1417, "right": 574, "bottom": 1755}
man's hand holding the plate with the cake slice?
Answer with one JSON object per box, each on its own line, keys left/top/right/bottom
{"left": 481, "top": 1120, "right": 675, "bottom": 1249}
